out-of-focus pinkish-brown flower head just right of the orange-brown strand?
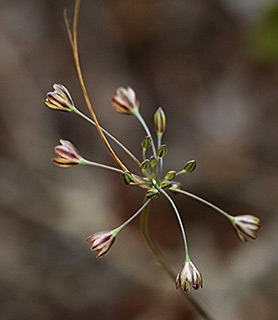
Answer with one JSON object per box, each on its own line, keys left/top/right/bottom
{"left": 112, "top": 87, "right": 139, "bottom": 114}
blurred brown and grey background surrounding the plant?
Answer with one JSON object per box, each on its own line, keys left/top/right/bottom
{"left": 0, "top": 0, "right": 278, "bottom": 320}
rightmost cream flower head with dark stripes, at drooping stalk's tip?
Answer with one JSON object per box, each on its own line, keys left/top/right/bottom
{"left": 232, "top": 215, "right": 261, "bottom": 242}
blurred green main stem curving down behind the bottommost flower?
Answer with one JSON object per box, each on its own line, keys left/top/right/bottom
{"left": 141, "top": 199, "right": 213, "bottom": 320}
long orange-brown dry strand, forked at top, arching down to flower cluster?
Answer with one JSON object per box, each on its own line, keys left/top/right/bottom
{"left": 64, "top": 0, "right": 129, "bottom": 171}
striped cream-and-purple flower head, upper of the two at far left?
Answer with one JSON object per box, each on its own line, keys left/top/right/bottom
{"left": 44, "top": 84, "right": 75, "bottom": 112}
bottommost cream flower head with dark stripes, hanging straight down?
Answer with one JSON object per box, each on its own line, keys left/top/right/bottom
{"left": 176, "top": 261, "right": 203, "bottom": 291}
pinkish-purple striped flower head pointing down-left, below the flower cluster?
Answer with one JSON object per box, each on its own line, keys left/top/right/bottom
{"left": 86, "top": 231, "right": 116, "bottom": 258}
